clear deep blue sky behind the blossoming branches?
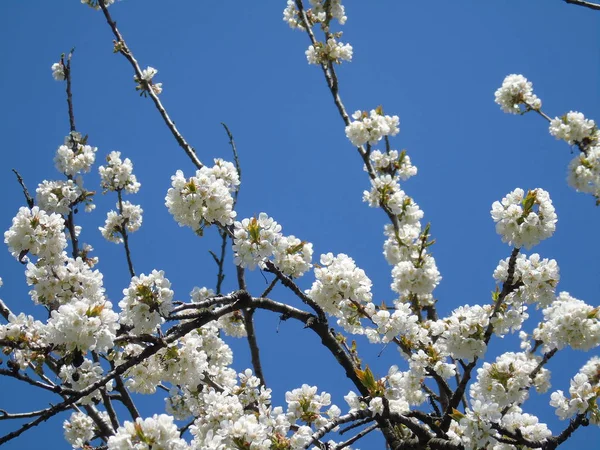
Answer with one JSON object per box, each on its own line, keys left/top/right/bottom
{"left": 0, "top": 0, "right": 600, "bottom": 449}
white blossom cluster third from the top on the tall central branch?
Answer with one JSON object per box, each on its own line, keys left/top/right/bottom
{"left": 346, "top": 107, "right": 400, "bottom": 147}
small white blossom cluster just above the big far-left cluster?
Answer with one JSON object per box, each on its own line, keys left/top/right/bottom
{"left": 35, "top": 180, "right": 90, "bottom": 216}
